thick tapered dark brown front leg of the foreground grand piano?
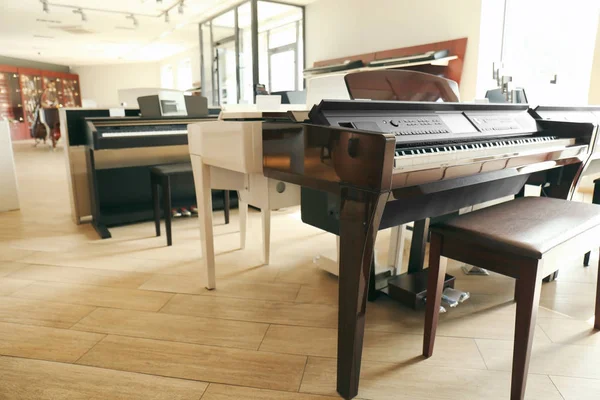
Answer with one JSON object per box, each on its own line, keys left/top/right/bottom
{"left": 337, "top": 188, "right": 389, "bottom": 399}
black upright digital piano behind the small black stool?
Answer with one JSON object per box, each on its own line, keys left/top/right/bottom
{"left": 85, "top": 116, "right": 216, "bottom": 239}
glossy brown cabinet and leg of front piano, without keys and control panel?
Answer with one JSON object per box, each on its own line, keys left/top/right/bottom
{"left": 263, "top": 119, "right": 587, "bottom": 399}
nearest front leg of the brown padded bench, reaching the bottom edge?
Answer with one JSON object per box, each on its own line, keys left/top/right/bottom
{"left": 510, "top": 260, "right": 542, "bottom": 400}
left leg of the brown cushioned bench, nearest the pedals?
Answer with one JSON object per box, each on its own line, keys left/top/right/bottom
{"left": 423, "top": 232, "right": 446, "bottom": 358}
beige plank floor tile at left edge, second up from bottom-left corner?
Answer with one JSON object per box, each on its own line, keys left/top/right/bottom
{"left": 0, "top": 322, "right": 104, "bottom": 362}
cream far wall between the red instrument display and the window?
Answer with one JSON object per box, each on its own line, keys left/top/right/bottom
{"left": 71, "top": 62, "right": 160, "bottom": 107}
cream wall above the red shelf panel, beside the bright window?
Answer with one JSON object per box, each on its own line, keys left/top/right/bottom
{"left": 306, "top": 0, "right": 491, "bottom": 100}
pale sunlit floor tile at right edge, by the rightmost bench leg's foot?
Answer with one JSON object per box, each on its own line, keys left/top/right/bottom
{"left": 537, "top": 318, "right": 600, "bottom": 346}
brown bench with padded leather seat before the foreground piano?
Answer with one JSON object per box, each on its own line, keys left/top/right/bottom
{"left": 423, "top": 197, "right": 600, "bottom": 400}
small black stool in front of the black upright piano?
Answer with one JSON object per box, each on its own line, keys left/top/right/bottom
{"left": 150, "top": 163, "right": 230, "bottom": 246}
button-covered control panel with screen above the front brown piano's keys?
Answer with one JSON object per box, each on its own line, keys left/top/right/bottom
{"left": 309, "top": 100, "right": 537, "bottom": 147}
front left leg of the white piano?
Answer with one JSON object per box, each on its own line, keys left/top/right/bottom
{"left": 191, "top": 155, "right": 216, "bottom": 289}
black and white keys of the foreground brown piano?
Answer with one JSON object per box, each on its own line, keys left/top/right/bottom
{"left": 394, "top": 136, "right": 575, "bottom": 172}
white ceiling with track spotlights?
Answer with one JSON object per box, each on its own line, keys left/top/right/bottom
{"left": 0, "top": 0, "right": 315, "bottom": 66}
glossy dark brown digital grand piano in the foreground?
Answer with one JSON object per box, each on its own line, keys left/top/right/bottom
{"left": 262, "top": 101, "right": 597, "bottom": 399}
